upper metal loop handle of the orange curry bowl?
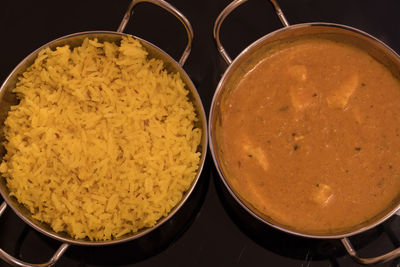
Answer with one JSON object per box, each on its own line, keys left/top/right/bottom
{"left": 213, "top": 0, "right": 289, "bottom": 65}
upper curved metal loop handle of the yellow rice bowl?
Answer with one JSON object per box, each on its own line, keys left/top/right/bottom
{"left": 117, "top": 0, "right": 193, "bottom": 66}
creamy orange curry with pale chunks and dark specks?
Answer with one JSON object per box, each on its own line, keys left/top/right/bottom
{"left": 220, "top": 39, "right": 400, "bottom": 234}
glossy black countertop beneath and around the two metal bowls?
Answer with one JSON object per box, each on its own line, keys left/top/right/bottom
{"left": 0, "top": 0, "right": 400, "bottom": 267}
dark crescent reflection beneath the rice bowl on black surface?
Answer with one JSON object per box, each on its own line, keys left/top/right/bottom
{"left": 7, "top": 158, "right": 210, "bottom": 266}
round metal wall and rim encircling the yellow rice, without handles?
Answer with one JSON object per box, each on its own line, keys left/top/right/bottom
{"left": 0, "top": 32, "right": 207, "bottom": 245}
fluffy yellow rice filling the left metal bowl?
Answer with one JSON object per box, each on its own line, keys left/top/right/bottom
{"left": 0, "top": 37, "right": 201, "bottom": 240}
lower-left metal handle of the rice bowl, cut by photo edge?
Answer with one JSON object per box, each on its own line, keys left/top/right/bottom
{"left": 0, "top": 201, "right": 69, "bottom": 267}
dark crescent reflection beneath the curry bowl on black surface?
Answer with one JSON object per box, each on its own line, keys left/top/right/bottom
{"left": 213, "top": 165, "right": 400, "bottom": 266}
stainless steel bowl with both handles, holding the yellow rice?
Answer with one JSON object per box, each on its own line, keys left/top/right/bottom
{"left": 0, "top": 0, "right": 207, "bottom": 266}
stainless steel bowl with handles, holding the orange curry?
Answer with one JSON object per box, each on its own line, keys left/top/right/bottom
{"left": 208, "top": 0, "right": 400, "bottom": 264}
